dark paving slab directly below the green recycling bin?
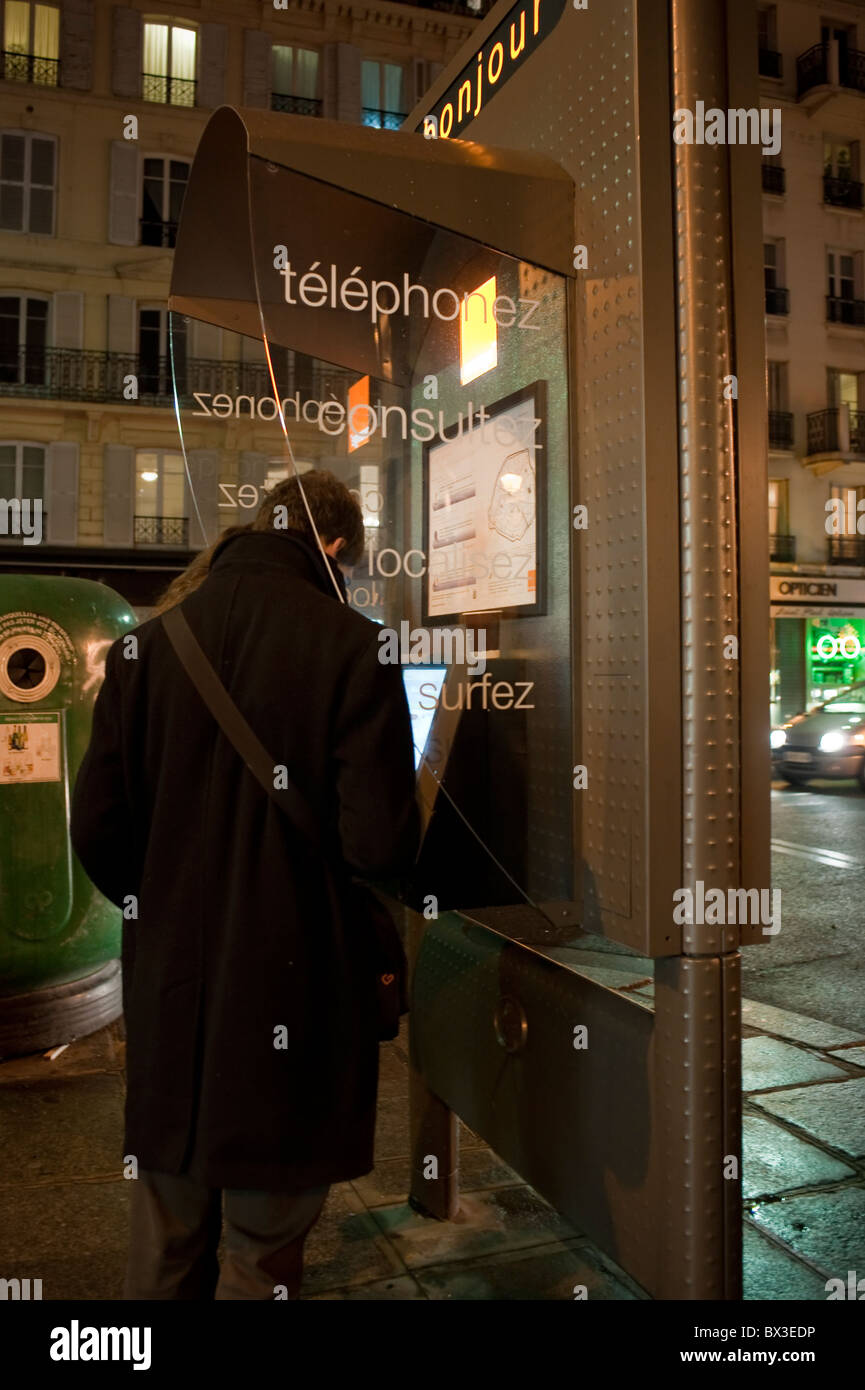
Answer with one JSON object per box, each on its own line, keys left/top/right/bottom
{"left": 0, "top": 1073, "right": 124, "bottom": 1187}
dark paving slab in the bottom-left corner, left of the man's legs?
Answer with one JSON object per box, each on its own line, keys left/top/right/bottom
{"left": 0, "top": 1179, "right": 131, "bottom": 1301}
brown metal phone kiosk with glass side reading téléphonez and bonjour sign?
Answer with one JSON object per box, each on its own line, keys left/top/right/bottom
{"left": 170, "top": 0, "right": 769, "bottom": 1298}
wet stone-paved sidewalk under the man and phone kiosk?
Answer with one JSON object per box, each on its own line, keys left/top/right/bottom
{"left": 0, "top": 1001, "right": 865, "bottom": 1300}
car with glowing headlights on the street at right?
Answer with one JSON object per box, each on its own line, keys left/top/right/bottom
{"left": 770, "top": 681, "right": 865, "bottom": 791}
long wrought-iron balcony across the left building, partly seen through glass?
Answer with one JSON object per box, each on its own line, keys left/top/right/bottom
{"left": 0, "top": 348, "right": 356, "bottom": 405}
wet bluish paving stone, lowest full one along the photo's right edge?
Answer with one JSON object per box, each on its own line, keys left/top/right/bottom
{"left": 751, "top": 1187, "right": 865, "bottom": 1278}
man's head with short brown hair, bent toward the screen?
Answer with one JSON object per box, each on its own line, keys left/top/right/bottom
{"left": 252, "top": 470, "right": 363, "bottom": 564}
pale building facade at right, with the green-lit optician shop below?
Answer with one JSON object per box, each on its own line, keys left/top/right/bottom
{"left": 759, "top": 0, "right": 865, "bottom": 723}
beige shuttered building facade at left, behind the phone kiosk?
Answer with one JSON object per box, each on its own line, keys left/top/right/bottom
{"left": 0, "top": 0, "right": 487, "bottom": 606}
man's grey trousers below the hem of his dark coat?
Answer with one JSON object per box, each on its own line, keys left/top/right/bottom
{"left": 124, "top": 1172, "right": 330, "bottom": 1300}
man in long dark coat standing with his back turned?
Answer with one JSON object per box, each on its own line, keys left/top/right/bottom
{"left": 71, "top": 473, "right": 419, "bottom": 1298}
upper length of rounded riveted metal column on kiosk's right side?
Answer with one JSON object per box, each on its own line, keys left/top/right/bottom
{"left": 672, "top": 0, "right": 740, "bottom": 955}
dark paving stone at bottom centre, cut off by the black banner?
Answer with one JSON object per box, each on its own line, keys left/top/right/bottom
{"left": 417, "top": 1241, "right": 636, "bottom": 1302}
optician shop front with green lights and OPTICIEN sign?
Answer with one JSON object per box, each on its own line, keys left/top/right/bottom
{"left": 769, "top": 574, "right": 865, "bottom": 726}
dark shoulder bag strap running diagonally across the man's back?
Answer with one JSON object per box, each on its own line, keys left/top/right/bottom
{"left": 161, "top": 607, "right": 323, "bottom": 851}
